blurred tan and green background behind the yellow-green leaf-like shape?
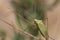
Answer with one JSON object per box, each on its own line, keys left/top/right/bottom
{"left": 0, "top": 0, "right": 60, "bottom": 40}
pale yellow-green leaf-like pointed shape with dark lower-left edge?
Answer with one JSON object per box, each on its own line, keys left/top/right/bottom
{"left": 34, "top": 19, "right": 47, "bottom": 37}
